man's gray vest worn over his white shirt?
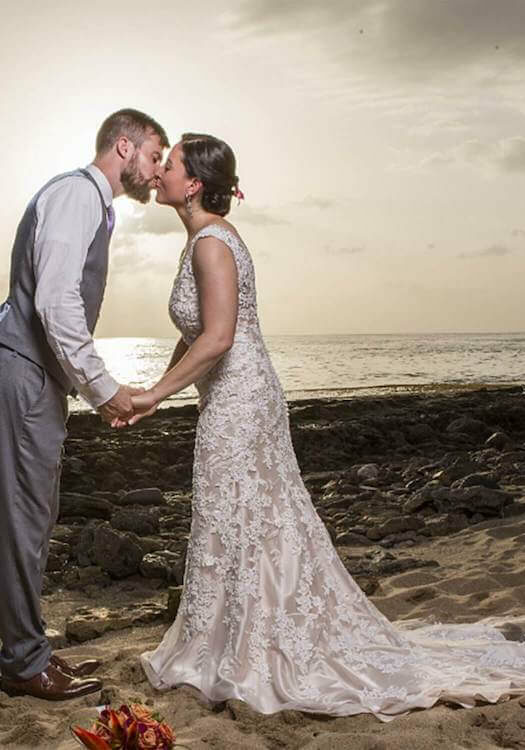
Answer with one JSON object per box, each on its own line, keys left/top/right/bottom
{"left": 0, "top": 169, "right": 110, "bottom": 393}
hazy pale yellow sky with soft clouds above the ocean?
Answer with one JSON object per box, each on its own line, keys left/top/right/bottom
{"left": 0, "top": 0, "right": 525, "bottom": 336}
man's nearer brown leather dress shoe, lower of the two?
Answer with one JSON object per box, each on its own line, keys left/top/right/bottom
{"left": 0, "top": 664, "right": 102, "bottom": 701}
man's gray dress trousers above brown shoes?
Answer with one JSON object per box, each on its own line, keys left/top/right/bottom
{"left": 0, "top": 345, "right": 67, "bottom": 680}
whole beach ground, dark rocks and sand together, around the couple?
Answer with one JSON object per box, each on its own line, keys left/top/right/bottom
{"left": 0, "top": 387, "right": 525, "bottom": 750}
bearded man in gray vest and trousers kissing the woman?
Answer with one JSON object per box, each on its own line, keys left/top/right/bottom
{"left": 0, "top": 109, "right": 169, "bottom": 700}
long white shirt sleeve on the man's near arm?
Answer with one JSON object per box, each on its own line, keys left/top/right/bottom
{"left": 34, "top": 177, "right": 119, "bottom": 409}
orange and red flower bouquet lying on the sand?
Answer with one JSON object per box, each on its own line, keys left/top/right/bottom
{"left": 71, "top": 703, "right": 188, "bottom": 750}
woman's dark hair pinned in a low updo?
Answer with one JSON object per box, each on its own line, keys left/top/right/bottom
{"left": 181, "top": 133, "right": 239, "bottom": 216}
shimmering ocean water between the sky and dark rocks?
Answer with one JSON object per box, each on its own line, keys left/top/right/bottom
{"left": 70, "top": 332, "right": 525, "bottom": 412}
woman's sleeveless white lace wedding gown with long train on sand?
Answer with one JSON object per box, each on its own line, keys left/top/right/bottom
{"left": 141, "top": 224, "right": 525, "bottom": 721}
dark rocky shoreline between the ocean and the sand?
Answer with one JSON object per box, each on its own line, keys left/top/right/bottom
{"left": 44, "top": 387, "right": 525, "bottom": 643}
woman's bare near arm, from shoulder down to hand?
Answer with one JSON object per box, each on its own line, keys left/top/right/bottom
{"left": 129, "top": 237, "right": 238, "bottom": 424}
